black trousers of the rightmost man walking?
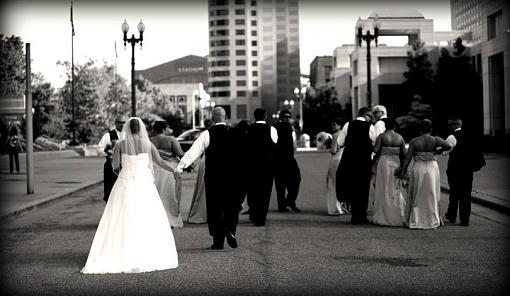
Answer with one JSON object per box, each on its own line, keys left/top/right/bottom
{"left": 445, "top": 169, "right": 473, "bottom": 224}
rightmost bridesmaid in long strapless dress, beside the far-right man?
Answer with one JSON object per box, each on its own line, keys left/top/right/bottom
{"left": 400, "top": 119, "right": 452, "bottom": 229}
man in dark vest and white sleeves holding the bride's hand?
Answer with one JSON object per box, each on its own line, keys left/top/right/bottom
{"left": 177, "top": 107, "right": 240, "bottom": 249}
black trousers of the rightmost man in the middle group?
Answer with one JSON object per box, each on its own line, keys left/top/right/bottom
{"left": 274, "top": 157, "right": 301, "bottom": 209}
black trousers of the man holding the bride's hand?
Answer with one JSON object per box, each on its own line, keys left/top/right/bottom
{"left": 204, "top": 175, "right": 240, "bottom": 244}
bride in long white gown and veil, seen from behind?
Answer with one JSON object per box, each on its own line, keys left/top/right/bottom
{"left": 81, "top": 117, "right": 178, "bottom": 273}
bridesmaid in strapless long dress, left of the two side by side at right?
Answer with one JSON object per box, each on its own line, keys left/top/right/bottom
{"left": 374, "top": 118, "right": 406, "bottom": 226}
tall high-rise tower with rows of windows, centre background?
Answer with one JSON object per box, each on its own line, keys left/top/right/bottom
{"left": 208, "top": 0, "right": 300, "bottom": 122}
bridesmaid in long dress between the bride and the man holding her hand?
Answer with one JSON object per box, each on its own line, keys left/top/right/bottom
{"left": 150, "top": 121, "right": 184, "bottom": 228}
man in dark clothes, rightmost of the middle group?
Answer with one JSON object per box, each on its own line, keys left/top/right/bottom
{"left": 274, "top": 110, "right": 301, "bottom": 212}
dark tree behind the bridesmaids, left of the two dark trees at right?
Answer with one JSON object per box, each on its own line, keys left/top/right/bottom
{"left": 403, "top": 40, "right": 434, "bottom": 102}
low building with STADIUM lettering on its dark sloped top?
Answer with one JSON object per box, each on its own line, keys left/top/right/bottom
{"left": 135, "top": 55, "right": 207, "bottom": 124}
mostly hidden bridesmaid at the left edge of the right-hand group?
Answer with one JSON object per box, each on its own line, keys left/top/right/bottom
{"left": 326, "top": 118, "right": 349, "bottom": 216}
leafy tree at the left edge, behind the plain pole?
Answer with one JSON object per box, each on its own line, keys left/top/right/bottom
{"left": 0, "top": 34, "right": 25, "bottom": 96}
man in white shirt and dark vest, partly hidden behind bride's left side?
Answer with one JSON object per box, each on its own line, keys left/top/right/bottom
{"left": 97, "top": 116, "right": 126, "bottom": 202}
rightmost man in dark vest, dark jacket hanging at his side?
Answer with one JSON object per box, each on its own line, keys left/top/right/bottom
{"left": 445, "top": 118, "right": 485, "bottom": 226}
